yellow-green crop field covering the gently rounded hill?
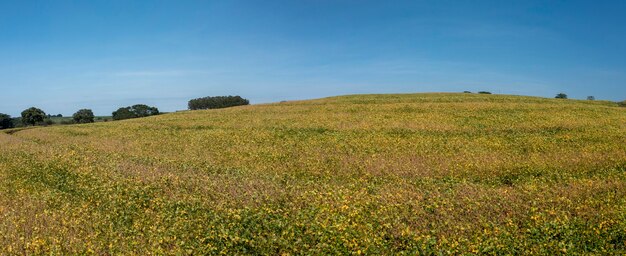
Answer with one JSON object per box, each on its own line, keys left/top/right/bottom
{"left": 0, "top": 94, "right": 626, "bottom": 255}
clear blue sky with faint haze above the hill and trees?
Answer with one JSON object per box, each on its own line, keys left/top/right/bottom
{"left": 0, "top": 0, "right": 626, "bottom": 116}
